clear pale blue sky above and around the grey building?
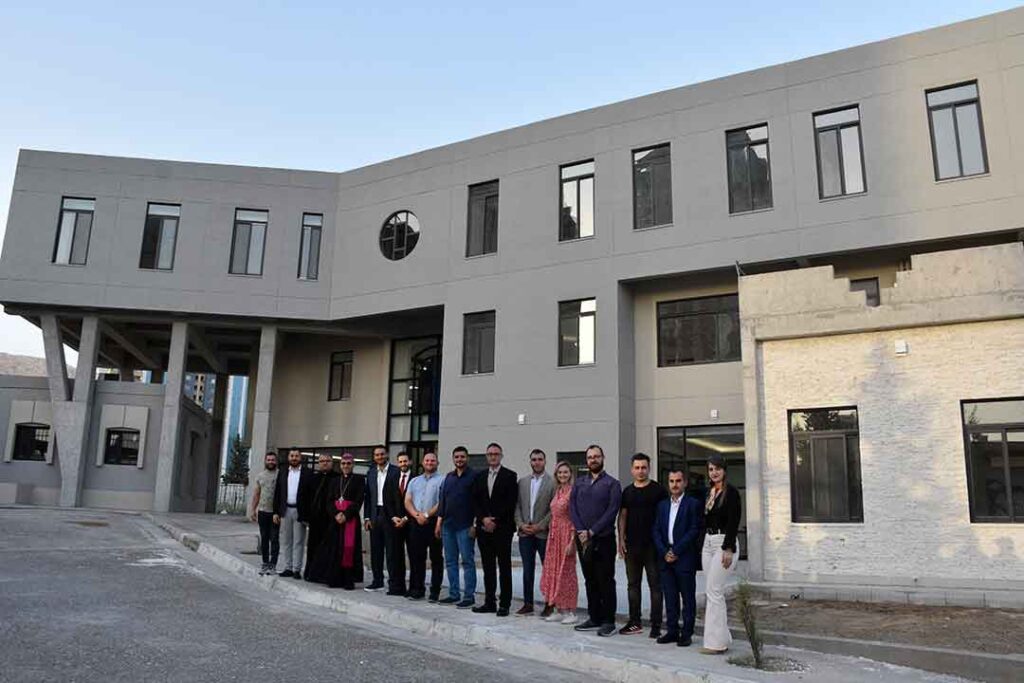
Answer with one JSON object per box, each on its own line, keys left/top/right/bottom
{"left": 0, "top": 0, "right": 1018, "bottom": 355}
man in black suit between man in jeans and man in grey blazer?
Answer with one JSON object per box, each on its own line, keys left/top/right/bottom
{"left": 473, "top": 443, "right": 519, "bottom": 616}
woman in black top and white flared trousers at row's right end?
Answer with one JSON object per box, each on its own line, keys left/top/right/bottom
{"left": 700, "top": 453, "right": 741, "bottom": 654}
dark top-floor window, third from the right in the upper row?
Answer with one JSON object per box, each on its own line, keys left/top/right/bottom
{"left": 725, "top": 123, "right": 771, "bottom": 213}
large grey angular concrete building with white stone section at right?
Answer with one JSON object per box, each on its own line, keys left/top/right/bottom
{"left": 0, "top": 9, "right": 1024, "bottom": 604}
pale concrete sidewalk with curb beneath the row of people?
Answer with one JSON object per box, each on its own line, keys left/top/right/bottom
{"left": 152, "top": 514, "right": 999, "bottom": 683}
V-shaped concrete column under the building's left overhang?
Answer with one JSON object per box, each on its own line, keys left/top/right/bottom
{"left": 42, "top": 315, "right": 99, "bottom": 507}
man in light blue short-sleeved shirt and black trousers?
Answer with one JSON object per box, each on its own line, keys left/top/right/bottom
{"left": 406, "top": 453, "right": 444, "bottom": 602}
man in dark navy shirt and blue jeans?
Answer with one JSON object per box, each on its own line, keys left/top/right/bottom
{"left": 434, "top": 445, "right": 476, "bottom": 609}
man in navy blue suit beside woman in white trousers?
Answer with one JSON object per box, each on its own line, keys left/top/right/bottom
{"left": 653, "top": 470, "right": 703, "bottom": 647}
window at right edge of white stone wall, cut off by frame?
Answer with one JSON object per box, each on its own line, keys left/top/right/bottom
{"left": 963, "top": 397, "right": 1024, "bottom": 523}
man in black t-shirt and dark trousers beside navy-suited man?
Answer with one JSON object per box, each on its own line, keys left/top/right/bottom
{"left": 618, "top": 453, "right": 669, "bottom": 638}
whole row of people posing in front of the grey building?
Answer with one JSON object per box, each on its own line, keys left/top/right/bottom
{"left": 250, "top": 443, "right": 740, "bottom": 654}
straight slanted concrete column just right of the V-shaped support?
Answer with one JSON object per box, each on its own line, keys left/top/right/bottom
{"left": 153, "top": 322, "right": 188, "bottom": 512}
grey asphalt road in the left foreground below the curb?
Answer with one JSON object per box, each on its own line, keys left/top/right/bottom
{"left": 0, "top": 508, "right": 593, "bottom": 683}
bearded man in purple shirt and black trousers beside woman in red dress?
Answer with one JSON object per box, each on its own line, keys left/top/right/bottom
{"left": 569, "top": 445, "right": 623, "bottom": 637}
